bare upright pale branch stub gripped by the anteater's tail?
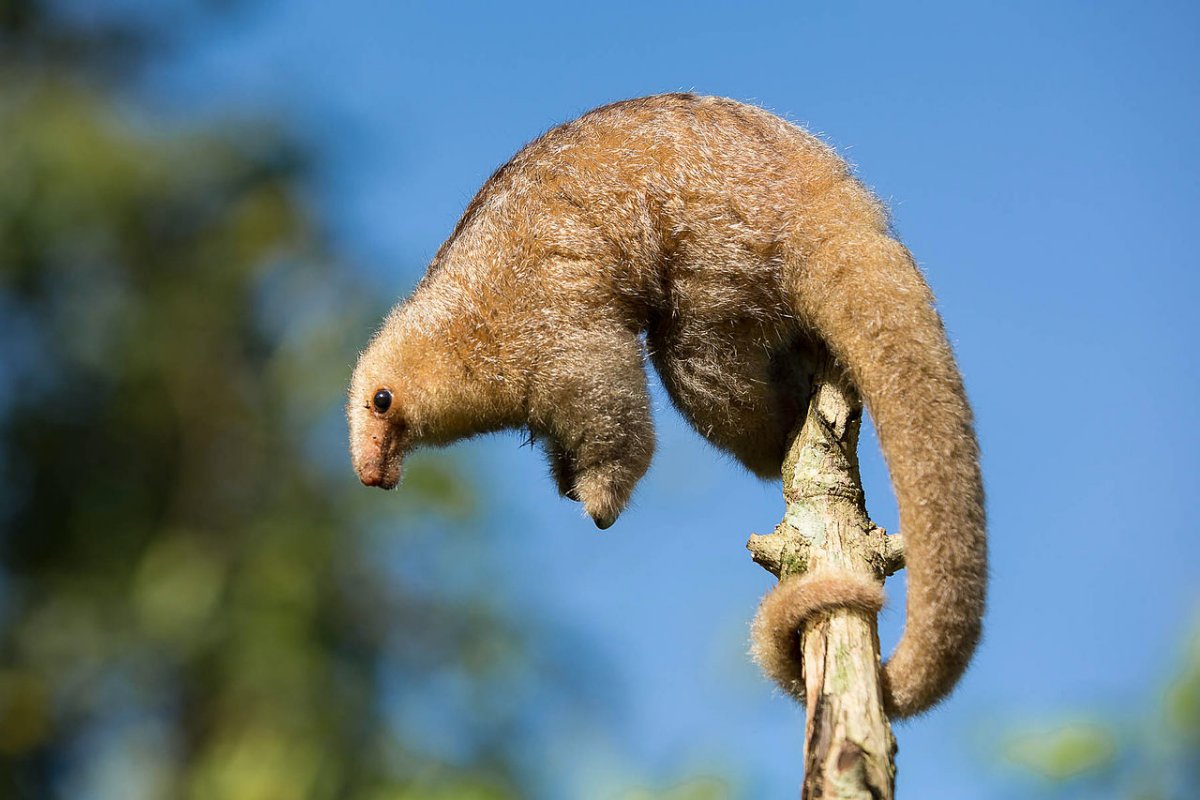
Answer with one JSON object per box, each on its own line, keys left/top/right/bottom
{"left": 746, "top": 369, "right": 904, "bottom": 800}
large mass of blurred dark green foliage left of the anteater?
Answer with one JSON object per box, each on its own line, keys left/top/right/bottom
{"left": 0, "top": 0, "right": 559, "bottom": 800}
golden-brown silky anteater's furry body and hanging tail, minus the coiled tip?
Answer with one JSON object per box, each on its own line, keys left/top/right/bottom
{"left": 348, "top": 95, "right": 986, "bottom": 715}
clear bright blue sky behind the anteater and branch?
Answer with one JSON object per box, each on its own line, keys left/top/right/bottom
{"left": 154, "top": 0, "right": 1200, "bottom": 798}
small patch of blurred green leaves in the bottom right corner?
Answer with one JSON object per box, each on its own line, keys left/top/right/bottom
{"left": 1002, "top": 627, "right": 1200, "bottom": 800}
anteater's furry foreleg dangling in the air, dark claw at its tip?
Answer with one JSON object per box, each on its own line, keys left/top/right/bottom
{"left": 529, "top": 320, "right": 654, "bottom": 529}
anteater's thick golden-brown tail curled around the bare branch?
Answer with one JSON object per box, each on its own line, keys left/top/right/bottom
{"left": 755, "top": 206, "right": 988, "bottom": 717}
